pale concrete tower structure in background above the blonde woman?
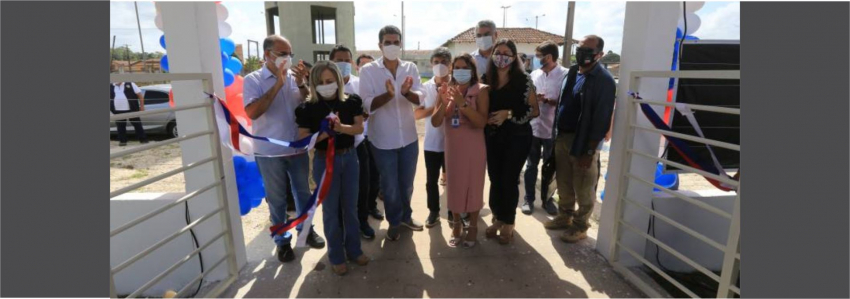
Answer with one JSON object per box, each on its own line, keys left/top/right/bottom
{"left": 266, "top": 2, "right": 357, "bottom": 63}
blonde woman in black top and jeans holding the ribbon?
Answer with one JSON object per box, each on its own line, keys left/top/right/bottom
{"left": 295, "top": 61, "right": 369, "bottom": 275}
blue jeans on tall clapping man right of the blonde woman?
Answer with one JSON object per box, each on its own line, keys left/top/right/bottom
{"left": 372, "top": 141, "right": 419, "bottom": 226}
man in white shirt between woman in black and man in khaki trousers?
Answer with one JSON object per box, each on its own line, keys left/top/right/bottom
{"left": 521, "top": 41, "right": 567, "bottom": 215}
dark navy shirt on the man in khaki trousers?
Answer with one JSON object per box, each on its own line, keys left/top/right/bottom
{"left": 555, "top": 63, "right": 617, "bottom": 157}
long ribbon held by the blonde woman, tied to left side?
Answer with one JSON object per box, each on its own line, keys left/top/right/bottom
{"left": 207, "top": 93, "right": 336, "bottom": 247}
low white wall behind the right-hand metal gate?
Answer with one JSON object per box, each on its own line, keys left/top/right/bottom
{"left": 644, "top": 190, "right": 735, "bottom": 272}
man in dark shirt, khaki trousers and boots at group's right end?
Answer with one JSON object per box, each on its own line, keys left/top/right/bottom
{"left": 544, "top": 35, "right": 617, "bottom": 242}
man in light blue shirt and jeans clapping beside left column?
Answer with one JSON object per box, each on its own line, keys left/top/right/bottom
{"left": 242, "top": 35, "right": 325, "bottom": 262}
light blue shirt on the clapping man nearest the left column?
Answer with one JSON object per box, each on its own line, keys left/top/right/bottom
{"left": 242, "top": 65, "right": 305, "bottom": 156}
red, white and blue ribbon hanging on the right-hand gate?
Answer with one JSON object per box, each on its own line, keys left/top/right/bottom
{"left": 629, "top": 92, "right": 737, "bottom": 191}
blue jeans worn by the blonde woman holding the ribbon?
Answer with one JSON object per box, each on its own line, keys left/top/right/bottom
{"left": 313, "top": 148, "right": 363, "bottom": 265}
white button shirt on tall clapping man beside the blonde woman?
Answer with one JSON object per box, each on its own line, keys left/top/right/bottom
{"left": 360, "top": 57, "right": 423, "bottom": 150}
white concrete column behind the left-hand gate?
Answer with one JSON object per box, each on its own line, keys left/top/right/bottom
{"left": 157, "top": 2, "right": 246, "bottom": 281}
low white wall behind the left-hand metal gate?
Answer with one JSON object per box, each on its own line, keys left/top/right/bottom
{"left": 109, "top": 191, "right": 229, "bottom": 297}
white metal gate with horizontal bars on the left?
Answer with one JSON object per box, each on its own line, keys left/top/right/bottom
{"left": 109, "top": 73, "right": 238, "bottom": 298}
